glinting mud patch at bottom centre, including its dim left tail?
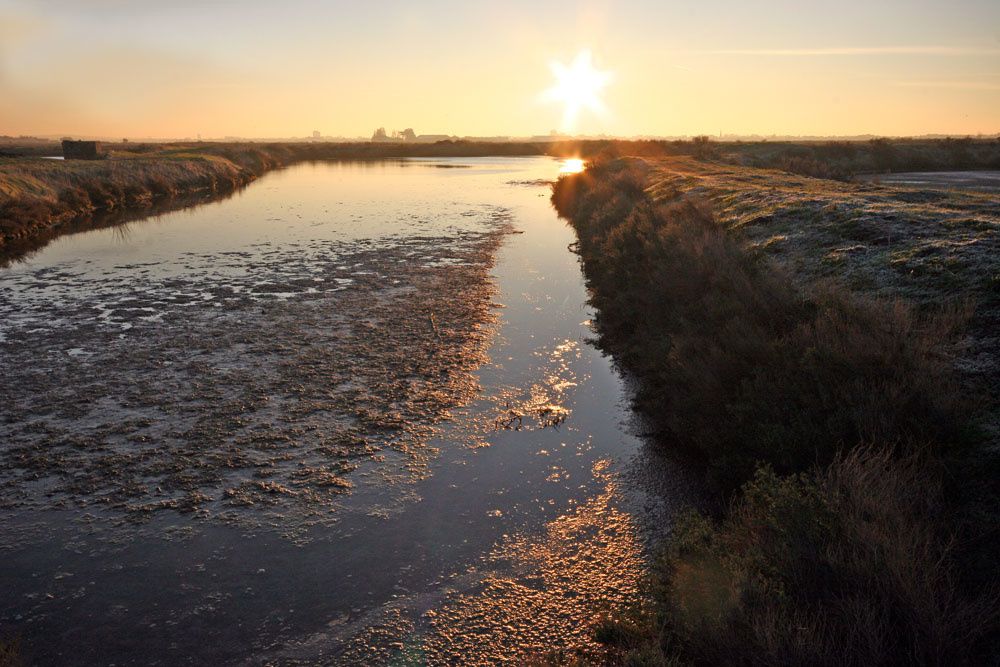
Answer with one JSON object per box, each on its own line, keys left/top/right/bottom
{"left": 271, "top": 460, "right": 645, "bottom": 665}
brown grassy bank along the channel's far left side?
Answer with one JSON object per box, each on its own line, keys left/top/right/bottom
{"left": 0, "top": 141, "right": 551, "bottom": 248}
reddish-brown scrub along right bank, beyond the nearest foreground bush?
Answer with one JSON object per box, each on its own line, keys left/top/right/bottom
{"left": 553, "top": 161, "right": 968, "bottom": 488}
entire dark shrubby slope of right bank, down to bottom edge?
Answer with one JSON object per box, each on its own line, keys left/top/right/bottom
{"left": 553, "top": 160, "right": 997, "bottom": 665}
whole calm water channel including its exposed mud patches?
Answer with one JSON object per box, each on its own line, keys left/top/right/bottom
{"left": 0, "top": 158, "right": 691, "bottom": 665}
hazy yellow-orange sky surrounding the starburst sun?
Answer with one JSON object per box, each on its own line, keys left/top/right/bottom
{"left": 0, "top": 0, "right": 1000, "bottom": 138}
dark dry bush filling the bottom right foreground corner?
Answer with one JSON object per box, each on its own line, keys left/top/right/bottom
{"left": 628, "top": 447, "right": 998, "bottom": 666}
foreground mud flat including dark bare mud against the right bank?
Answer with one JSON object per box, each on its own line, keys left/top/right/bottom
{"left": 245, "top": 450, "right": 698, "bottom": 666}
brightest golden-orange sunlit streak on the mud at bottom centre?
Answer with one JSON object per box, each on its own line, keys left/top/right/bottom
{"left": 421, "top": 460, "right": 645, "bottom": 665}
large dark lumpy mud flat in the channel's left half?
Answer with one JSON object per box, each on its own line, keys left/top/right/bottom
{"left": 0, "top": 217, "right": 507, "bottom": 531}
